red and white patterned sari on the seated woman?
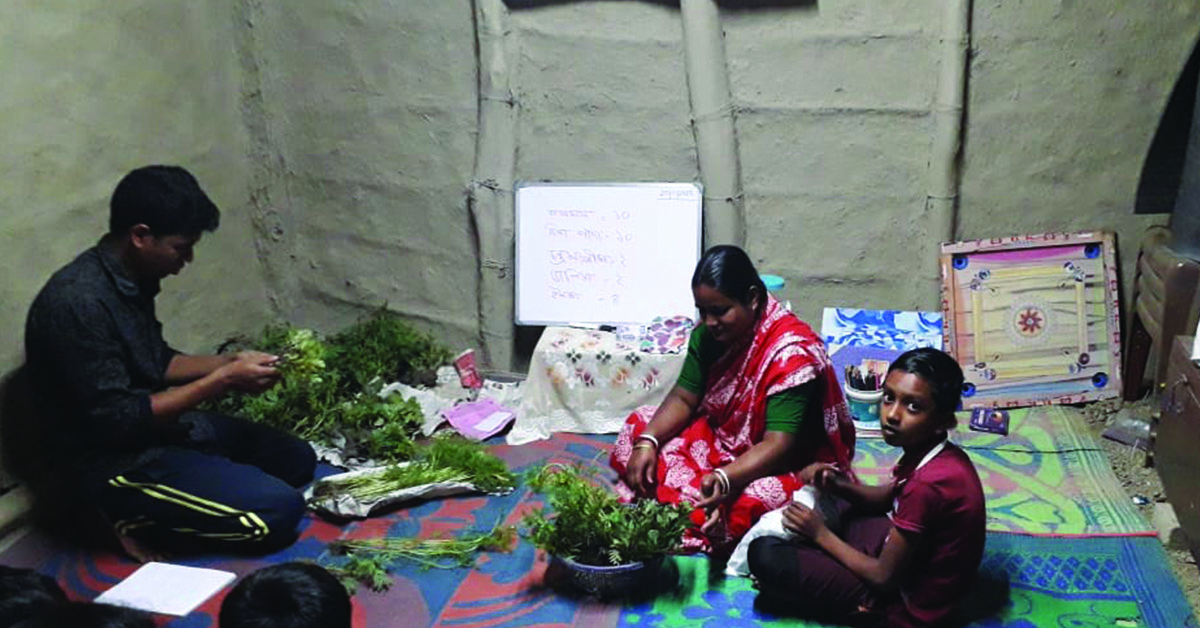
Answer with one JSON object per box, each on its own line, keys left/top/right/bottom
{"left": 608, "top": 295, "right": 854, "bottom": 551}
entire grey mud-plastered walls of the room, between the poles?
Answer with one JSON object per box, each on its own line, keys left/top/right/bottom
{"left": 0, "top": 0, "right": 1200, "bottom": 403}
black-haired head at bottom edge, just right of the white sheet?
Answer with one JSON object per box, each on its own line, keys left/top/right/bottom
{"left": 218, "top": 562, "right": 350, "bottom": 628}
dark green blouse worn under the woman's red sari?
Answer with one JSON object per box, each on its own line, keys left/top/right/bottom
{"left": 676, "top": 325, "right": 822, "bottom": 433}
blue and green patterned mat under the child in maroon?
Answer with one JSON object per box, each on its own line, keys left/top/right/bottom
{"left": 618, "top": 532, "right": 1196, "bottom": 628}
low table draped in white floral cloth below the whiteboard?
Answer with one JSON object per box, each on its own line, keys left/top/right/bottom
{"left": 506, "top": 322, "right": 691, "bottom": 444}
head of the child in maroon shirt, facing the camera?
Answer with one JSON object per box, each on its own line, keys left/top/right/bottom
{"left": 880, "top": 348, "right": 962, "bottom": 447}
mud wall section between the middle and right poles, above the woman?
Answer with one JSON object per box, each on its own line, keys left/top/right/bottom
{"left": 725, "top": 0, "right": 942, "bottom": 325}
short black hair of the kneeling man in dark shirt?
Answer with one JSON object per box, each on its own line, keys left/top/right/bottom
{"left": 108, "top": 166, "right": 221, "bottom": 235}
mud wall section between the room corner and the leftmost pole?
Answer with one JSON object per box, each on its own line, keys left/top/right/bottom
{"left": 247, "top": 0, "right": 479, "bottom": 348}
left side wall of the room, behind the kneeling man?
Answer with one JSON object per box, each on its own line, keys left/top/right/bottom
{"left": 0, "top": 0, "right": 269, "bottom": 485}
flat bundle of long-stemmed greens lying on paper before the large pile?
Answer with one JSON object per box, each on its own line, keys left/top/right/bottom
{"left": 312, "top": 435, "right": 516, "bottom": 503}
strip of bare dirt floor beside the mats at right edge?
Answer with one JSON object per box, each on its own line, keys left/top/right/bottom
{"left": 1084, "top": 399, "right": 1200, "bottom": 617}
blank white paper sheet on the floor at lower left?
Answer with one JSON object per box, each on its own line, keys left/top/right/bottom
{"left": 96, "top": 562, "right": 238, "bottom": 616}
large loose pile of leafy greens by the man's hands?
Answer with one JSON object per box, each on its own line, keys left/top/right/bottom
{"left": 208, "top": 307, "right": 451, "bottom": 461}
